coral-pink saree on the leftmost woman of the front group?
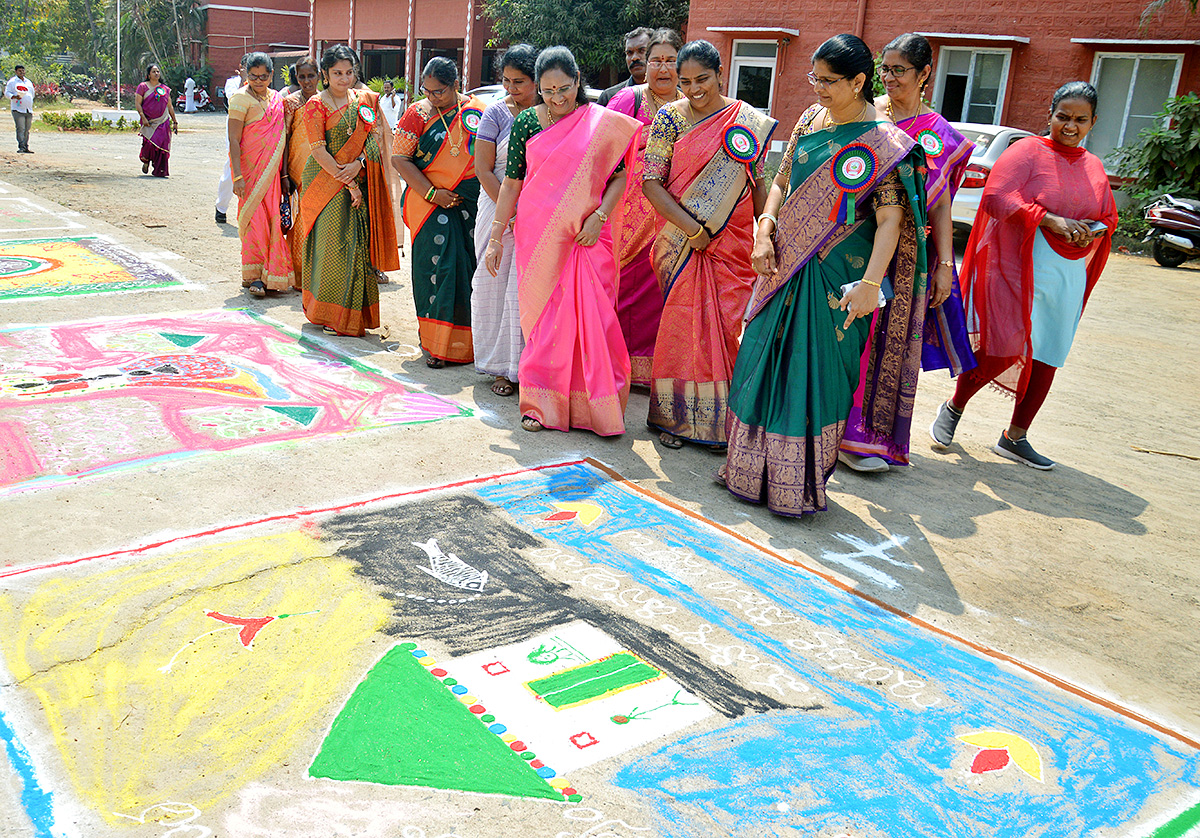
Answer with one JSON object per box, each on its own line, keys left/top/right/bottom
{"left": 238, "top": 90, "right": 294, "bottom": 291}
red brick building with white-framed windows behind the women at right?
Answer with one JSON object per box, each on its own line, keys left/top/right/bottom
{"left": 688, "top": 0, "right": 1200, "bottom": 162}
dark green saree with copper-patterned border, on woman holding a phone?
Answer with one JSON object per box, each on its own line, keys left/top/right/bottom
{"left": 725, "top": 122, "right": 925, "bottom": 516}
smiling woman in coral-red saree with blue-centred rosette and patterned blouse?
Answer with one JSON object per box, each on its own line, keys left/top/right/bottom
{"left": 642, "top": 41, "right": 776, "bottom": 450}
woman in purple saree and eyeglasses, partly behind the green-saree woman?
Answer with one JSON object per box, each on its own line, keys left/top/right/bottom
{"left": 839, "top": 34, "right": 976, "bottom": 472}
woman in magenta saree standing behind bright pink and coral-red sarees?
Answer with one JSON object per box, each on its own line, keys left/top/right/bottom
{"left": 607, "top": 29, "right": 683, "bottom": 387}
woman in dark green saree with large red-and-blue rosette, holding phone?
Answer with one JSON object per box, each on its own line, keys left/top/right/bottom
{"left": 718, "top": 35, "right": 925, "bottom": 516}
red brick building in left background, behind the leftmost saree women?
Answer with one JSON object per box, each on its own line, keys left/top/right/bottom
{"left": 200, "top": 0, "right": 310, "bottom": 90}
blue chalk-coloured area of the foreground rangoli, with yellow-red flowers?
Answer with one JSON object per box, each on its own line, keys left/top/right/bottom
{"left": 475, "top": 465, "right": 1200, "bottom": 838}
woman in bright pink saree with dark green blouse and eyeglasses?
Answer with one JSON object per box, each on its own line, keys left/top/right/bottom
{"left": 485, "top": 47, "right": 641, "bottom": 436}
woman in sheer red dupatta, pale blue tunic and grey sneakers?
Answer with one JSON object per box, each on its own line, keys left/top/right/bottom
{"left": 930, "top": 82, "right": 1117, "bottom": 471}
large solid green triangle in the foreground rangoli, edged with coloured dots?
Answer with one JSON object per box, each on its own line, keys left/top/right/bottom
{"left": 308, "top": 646, "right": 563, "bottom": 801}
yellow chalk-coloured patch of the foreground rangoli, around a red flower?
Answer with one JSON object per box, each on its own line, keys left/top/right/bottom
{"left": 0, "top": 532, "right": 390, "bottom": 824}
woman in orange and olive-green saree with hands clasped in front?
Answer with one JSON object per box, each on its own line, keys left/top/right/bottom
{"left": 300, "top": 44, "right": 400, "bottom": 337}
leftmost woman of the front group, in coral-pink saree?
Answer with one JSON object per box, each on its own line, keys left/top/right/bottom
{"left": 229, "top": 53, "right": 294, "bottom": 297}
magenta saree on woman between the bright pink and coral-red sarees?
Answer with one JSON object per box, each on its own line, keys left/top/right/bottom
{"left": 608, "top": 86, "right": 664, "bottom": 387}
